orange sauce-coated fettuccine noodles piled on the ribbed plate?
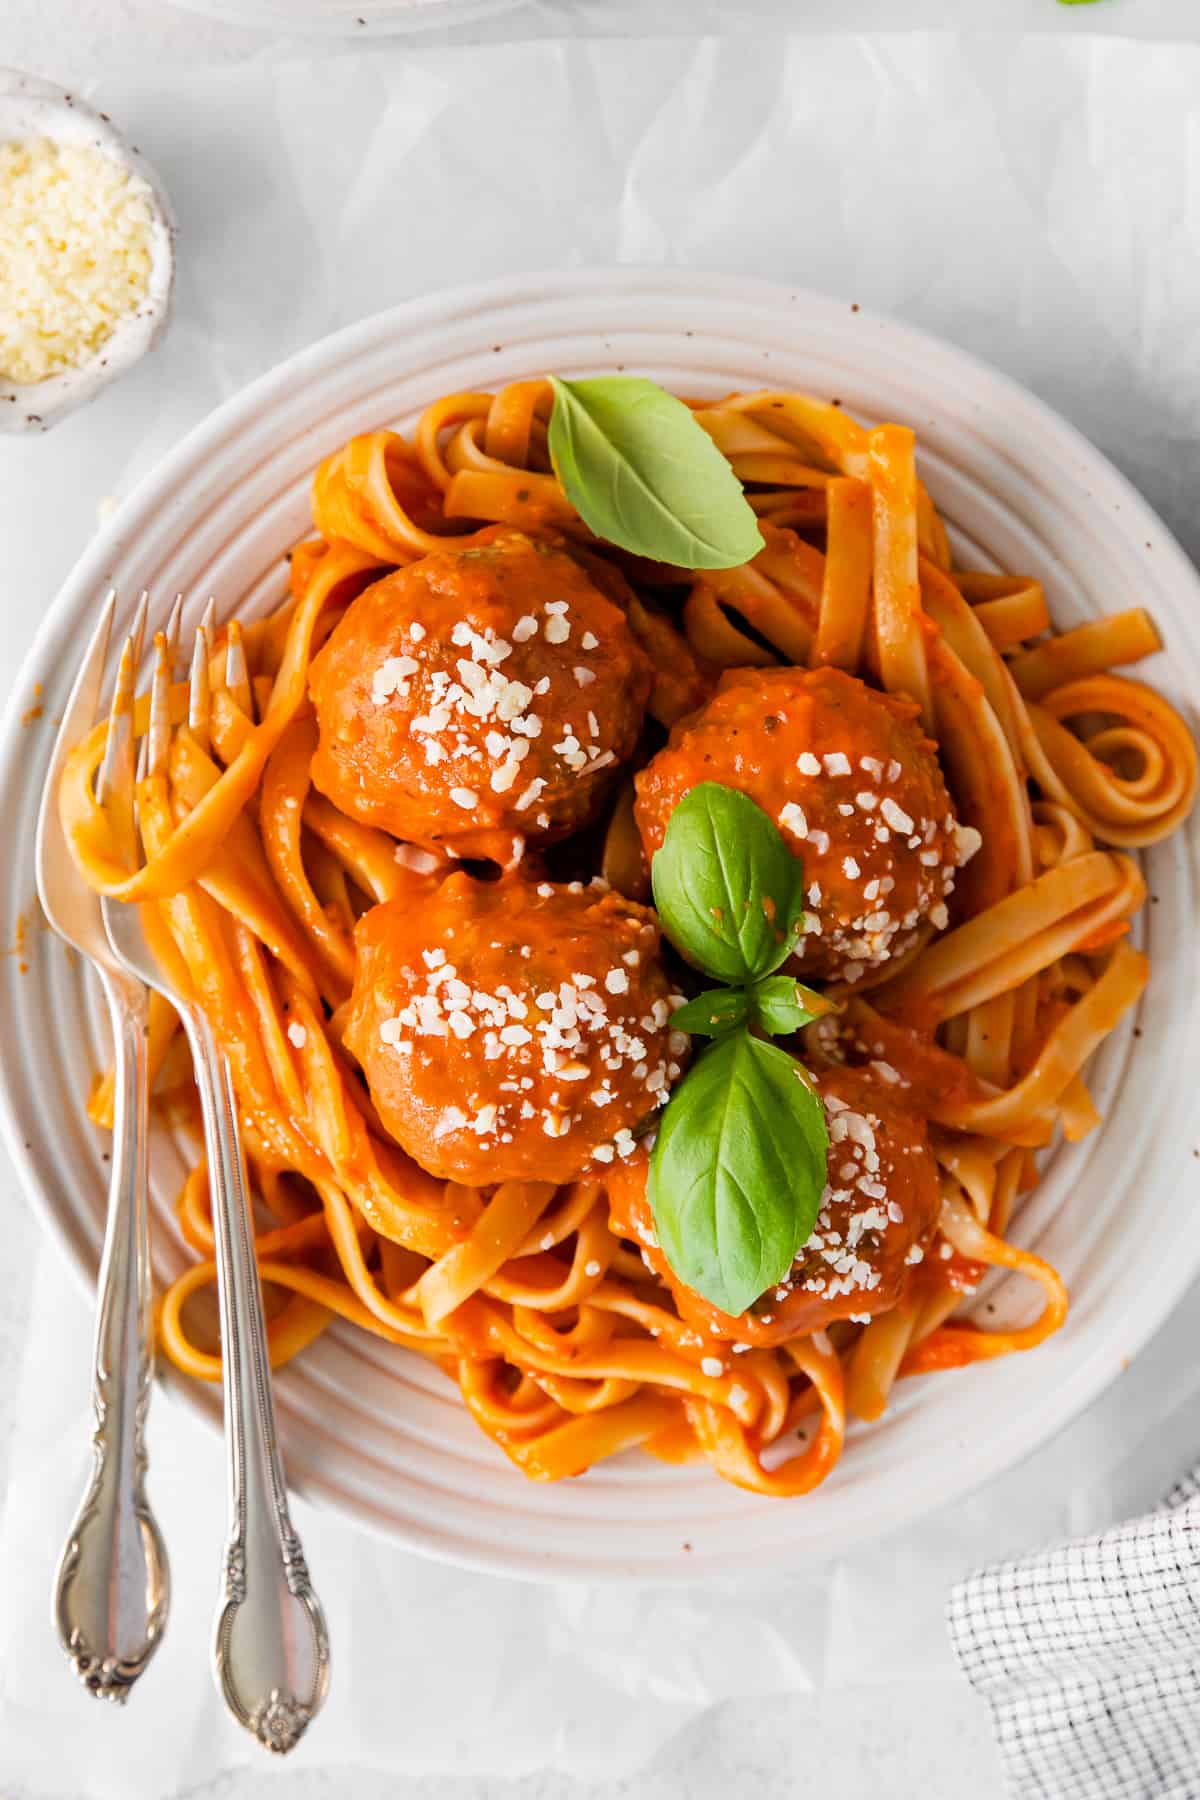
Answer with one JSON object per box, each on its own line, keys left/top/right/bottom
{"left": 61, "top": 382, "right": 1196, "bottom": 1496}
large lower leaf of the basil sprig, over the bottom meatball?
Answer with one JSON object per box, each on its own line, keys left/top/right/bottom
{"left": 648, "top": 1031, "right": 829, "bottom": 1316}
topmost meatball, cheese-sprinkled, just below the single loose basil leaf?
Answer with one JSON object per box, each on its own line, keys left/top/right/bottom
{"left": 309, "top": 529, "right": 651, "bottom": 862}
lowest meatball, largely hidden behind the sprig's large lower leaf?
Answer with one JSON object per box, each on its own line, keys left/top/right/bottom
{"left": 610, "top": 1069, "right": 941, "bottom": 1346}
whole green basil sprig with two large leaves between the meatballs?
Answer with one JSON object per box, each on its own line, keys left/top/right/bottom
{"left": 648, "top": 781, "right": 829, "bottom": 1316}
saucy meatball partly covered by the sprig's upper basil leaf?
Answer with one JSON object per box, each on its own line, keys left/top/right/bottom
{"left": 635, "top": 670, "right": 973, "bottom": 983}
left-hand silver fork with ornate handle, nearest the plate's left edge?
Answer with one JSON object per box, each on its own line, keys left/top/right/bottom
{"left": 36, "top": 594, "right": 171, "bottom": 1701}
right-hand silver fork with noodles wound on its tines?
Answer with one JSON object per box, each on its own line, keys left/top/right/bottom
{"left": 101, "top": 607, "right": 329, "bottom": 1751}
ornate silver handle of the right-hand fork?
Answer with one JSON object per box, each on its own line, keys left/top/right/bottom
{"left": 187, "top": 1008, "right": 329, "bottom": 1751}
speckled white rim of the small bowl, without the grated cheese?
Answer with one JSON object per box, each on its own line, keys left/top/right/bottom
{"left": 0, "top": 68, "right": 175, "bottom": 432}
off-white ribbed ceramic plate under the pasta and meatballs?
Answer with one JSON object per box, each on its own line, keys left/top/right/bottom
{"left": 0, "top": 270, "right": 1200, "bottom": 1580}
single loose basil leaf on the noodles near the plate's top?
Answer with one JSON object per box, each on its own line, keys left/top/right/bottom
{"left": 549, "top": 374, "right": 763, "bottom": 569}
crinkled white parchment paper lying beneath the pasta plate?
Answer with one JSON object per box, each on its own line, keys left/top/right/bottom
{"left": 0, "top": 31, "right": 1200, "bottom": 1800}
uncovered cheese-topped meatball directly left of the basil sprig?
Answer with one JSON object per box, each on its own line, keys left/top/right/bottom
{"left": 345, "top": 871, "right": 687, "bottom": 1184}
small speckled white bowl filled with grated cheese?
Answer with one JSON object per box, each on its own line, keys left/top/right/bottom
{"left": 0, "top": 68, "right": 175, "bottom": 432}
